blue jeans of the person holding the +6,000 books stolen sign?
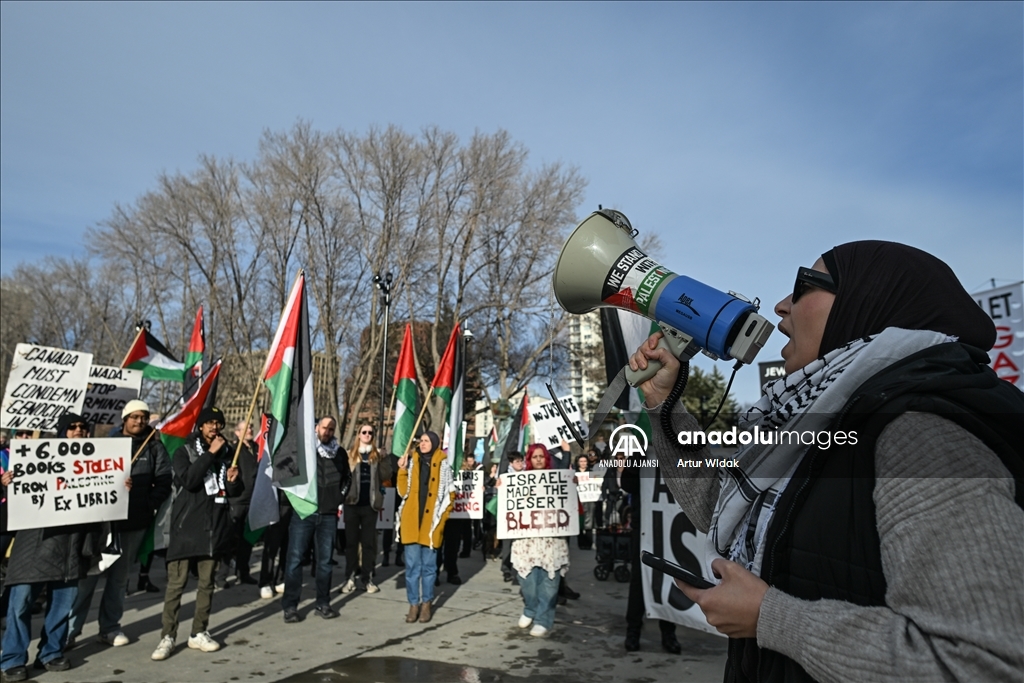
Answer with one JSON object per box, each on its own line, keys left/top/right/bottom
{"left": 0, "top": 581, "right": 78, "bottom": 671}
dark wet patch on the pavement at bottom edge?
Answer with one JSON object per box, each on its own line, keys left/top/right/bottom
{"left": 282, "top": 657, "right": 593, "bottom": 683}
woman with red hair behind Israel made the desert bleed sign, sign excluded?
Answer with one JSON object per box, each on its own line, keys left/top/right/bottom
{"left": 511, "top": 443, "right": 569, "bottom": 637}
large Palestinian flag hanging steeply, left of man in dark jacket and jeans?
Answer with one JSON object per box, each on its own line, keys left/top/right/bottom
{"left": 263, "top": 270, "right": 316, "bottom": 519}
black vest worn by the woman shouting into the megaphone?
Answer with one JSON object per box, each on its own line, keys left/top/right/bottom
{"left": 725, "top": 343, "right": 1024, "bottom": 683}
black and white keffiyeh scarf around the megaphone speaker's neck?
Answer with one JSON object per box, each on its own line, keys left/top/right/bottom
{"left": 705, "top": 328, "right": 955, "bottom": 577}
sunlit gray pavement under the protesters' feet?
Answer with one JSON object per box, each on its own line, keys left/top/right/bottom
{"left": 14, "top": 541, "right": 726, "bottom": 683}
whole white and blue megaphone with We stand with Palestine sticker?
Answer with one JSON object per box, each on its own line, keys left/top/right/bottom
{"left": 554, "top": 209, "right": 775, "bottom": 386}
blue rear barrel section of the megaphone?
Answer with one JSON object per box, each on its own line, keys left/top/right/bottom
{"left": 653, "top": 275, "right": 757, "bottom": 360}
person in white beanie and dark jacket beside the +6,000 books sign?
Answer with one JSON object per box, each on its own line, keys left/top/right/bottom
{"left": 68, "top": 399, "right": 173, "bottom": 648}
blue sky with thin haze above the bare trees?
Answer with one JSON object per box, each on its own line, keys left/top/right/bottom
{"left": 0, "top": 2, "right": 1024, "bottom": 401}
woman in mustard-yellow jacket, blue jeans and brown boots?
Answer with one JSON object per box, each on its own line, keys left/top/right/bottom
{"left": 397, "top": 432, "right": 455, "bottom": 624}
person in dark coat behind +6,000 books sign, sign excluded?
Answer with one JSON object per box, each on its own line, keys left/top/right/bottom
{"left": 0, "top": 413, "right": 101, "bottom": 683}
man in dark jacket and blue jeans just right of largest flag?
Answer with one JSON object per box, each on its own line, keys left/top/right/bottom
{"left": 282, "top": 416, "right": 351, "bottom": 624}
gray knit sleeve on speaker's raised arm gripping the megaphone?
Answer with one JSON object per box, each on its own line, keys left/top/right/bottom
{"left": 647, "top": 401, "right": 719, "bottom": 533}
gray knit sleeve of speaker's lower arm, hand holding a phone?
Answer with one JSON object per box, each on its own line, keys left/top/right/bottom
{"left": 758, "top": 413, "right": 1024, "bottom": 682}
